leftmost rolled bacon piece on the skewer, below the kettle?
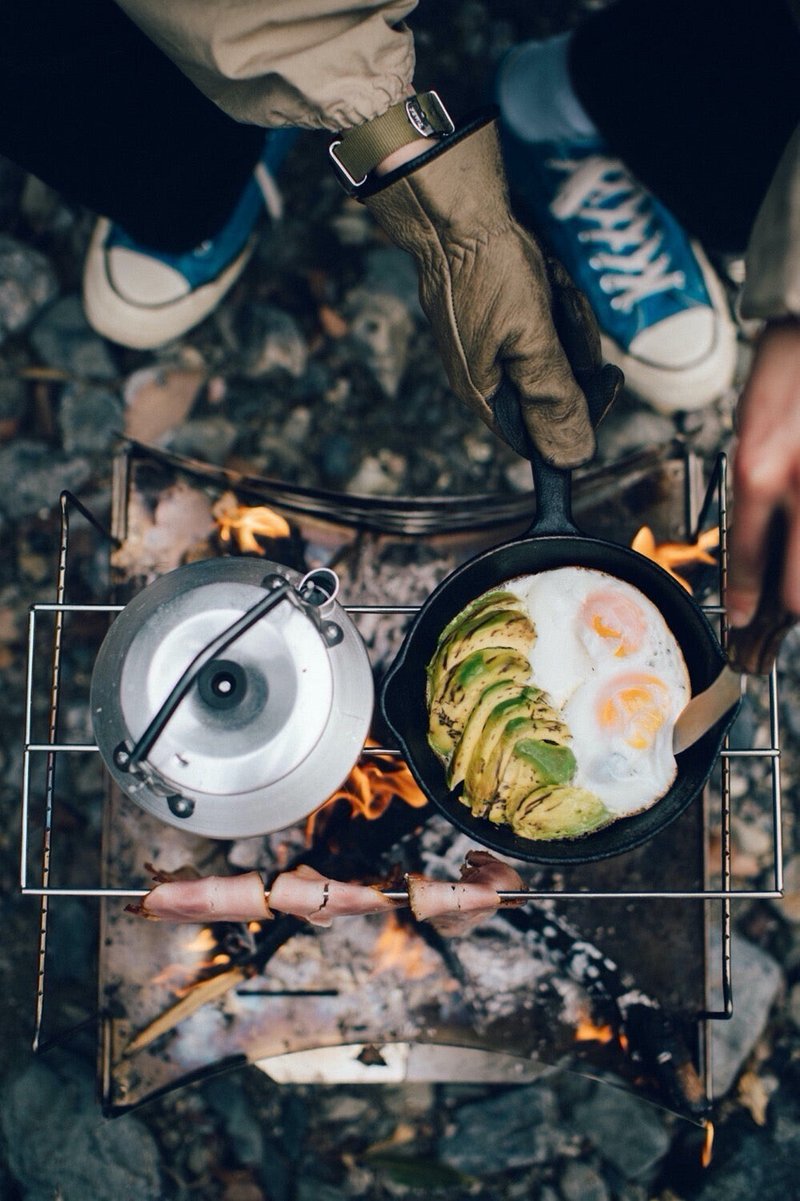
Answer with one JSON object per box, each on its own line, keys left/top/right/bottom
{"left": 125, "top": 872, "right": 273, "bottom": 925}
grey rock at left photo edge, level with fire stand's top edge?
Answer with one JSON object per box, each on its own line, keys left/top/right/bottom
{"left": 0, "top": 438, "right": 91, "bottom": 519}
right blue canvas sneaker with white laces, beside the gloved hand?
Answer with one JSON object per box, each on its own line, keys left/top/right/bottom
{"left": 501, "top": 125, "right": 736, "bottom": 413}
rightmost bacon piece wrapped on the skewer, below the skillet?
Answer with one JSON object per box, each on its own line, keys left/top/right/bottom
{"left": 407, "top": 850, "right": 523, "bottom": 938}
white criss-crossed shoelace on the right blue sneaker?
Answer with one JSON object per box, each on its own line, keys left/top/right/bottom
{"left": 548, "top": 155, "right": 686, "bottom": 312}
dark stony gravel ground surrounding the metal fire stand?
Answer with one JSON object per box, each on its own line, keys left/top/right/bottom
{"left": 0, "top": 0, "right": 800, "bottom": 1201}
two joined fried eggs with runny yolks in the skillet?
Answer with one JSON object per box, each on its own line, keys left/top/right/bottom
{"left": 507, "top": 567, "right": 691, "bottom": 817}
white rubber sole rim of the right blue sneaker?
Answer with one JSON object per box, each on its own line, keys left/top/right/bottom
{"left": 601, "top": 244, "right": 736, "bottom": 414}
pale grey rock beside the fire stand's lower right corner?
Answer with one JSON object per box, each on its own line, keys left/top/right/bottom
{"left": 711, "top": 934, "right": 783, "bottom": 1097}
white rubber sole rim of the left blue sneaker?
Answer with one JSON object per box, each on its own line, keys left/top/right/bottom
{"left": 83, "top": 217, "right": 257, "bottom": 351}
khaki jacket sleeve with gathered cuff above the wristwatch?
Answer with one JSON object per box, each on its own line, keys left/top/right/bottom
{"left": 118, "top": 0, "right": 417, "bottom": 130}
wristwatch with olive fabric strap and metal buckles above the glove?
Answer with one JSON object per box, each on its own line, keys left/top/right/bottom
{"left": 328, "top": 91, "right": 455, "bottom": 192}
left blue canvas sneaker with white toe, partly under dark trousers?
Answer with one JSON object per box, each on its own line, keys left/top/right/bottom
{"left": 83, "top": 130, "right": 298, "bottom": 349}
